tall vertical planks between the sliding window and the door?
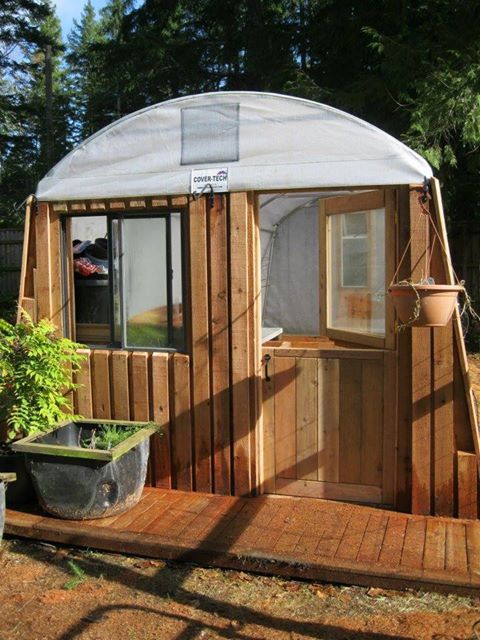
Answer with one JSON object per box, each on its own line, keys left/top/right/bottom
{"left": 189, "top": 193, "right": 260, "bottom": 495}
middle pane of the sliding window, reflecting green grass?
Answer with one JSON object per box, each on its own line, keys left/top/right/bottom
{"left": 122, "top": 218, "right": 169, "bottom": 348}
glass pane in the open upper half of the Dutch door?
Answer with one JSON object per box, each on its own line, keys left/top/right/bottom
{"left": 328, "top": 209, "right": 385, "bottom": 336}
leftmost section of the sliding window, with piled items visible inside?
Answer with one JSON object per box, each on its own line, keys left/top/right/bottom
{"left": 71, "top": 216, "right": 111, "bottom": 344}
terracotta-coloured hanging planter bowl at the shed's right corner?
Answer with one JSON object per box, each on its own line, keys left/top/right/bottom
{"left": 388, "top": 282, "right": 463, "bottom": 327}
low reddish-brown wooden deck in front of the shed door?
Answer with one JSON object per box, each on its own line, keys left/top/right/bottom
{"left": 5, "top": 489, "right": 480, "bottom": 596}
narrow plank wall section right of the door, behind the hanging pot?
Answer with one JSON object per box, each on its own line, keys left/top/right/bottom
{"left": 397, "top": 183, "right": 478, "bottom": 517}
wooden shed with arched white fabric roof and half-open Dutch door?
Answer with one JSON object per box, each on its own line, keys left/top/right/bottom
{"left": 15, "top": 92, "right": 479, "bottom": 518}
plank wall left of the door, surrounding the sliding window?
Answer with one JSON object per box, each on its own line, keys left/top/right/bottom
{"left": 20, "top": 193, "right": 261, "bottom": 495}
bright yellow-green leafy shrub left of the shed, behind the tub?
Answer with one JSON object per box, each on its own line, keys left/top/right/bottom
{"left": 0, "top": 314, "right": 83, "bottom": 440}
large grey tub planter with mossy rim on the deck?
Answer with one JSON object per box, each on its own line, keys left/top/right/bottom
{"left": 13, "top": 420, "right": 158, "bottom": 520}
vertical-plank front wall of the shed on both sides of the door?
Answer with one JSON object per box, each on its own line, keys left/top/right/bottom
{"left": 16, "top": 187, "right": 480, "bottom": 517}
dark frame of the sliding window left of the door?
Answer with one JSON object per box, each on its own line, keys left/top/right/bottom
{"left": 61, "top": 207, "right": 189, "bottom": 353}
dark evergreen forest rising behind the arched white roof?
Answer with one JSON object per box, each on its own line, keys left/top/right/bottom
{"left": 0, "top": 0, "right": 480, "bottom": 330}
